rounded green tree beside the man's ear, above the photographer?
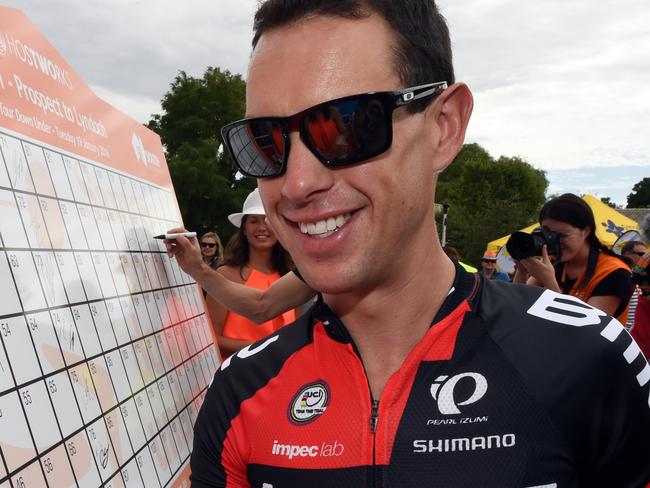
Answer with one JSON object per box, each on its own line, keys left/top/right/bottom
{"left": 436, "top": 144, "right": 548, "bottom": 265}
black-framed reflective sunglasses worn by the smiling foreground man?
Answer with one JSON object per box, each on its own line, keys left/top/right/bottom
{"left": 221, "top": 81, "right": 447, "bottom": 178}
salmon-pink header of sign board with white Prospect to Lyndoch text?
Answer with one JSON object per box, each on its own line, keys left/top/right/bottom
{"left": 0, "top": 7, "right": 172, "bottom": 188}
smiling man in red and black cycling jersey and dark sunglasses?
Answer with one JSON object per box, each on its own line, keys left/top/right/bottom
{"left": 167, "top": 0, "right": 650, "bottom": 488}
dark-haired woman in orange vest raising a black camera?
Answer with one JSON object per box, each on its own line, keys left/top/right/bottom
{"left": 513, "top": 193, "right": 633, "bottom": 324}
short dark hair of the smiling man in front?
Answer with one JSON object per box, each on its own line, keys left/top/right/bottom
{"left": 253, "top": 0, "right": 454, "bottom": 112}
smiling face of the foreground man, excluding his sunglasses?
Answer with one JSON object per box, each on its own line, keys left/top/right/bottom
{"left": 247, "top": 15, "right": 441, "bottom": 293}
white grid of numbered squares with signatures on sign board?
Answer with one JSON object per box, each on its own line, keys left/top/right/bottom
{"left": 0, "top": 132, "right": 219, "bottom": 488}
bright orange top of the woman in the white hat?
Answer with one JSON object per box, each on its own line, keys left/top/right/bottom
{"left": 222, "top": 268, "right": 296, "bottom": 342}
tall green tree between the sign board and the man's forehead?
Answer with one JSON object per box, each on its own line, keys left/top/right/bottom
{"left": 147, "top": 67, "right": 256, "bottom": 240}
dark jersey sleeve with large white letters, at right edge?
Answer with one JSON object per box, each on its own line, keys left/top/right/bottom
{"left": 481, "top": 283, "right": 650, "bottom": 488}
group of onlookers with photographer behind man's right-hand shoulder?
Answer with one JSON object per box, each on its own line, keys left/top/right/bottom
{"left": 481, "top": 193, "right": 650, "bottom": 357}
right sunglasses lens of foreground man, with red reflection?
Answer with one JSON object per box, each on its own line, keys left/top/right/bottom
{"left": 303, "top": 96, "right": 392, "bottom": 165}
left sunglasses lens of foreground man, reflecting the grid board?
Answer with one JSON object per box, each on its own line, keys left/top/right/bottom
{"left": 225, "top": 119, "right": 285, "bottom": 178}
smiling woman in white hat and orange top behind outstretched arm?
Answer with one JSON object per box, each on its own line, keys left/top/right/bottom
{"left": 206, "top": 190, "right": 295, "bottom": 359}
